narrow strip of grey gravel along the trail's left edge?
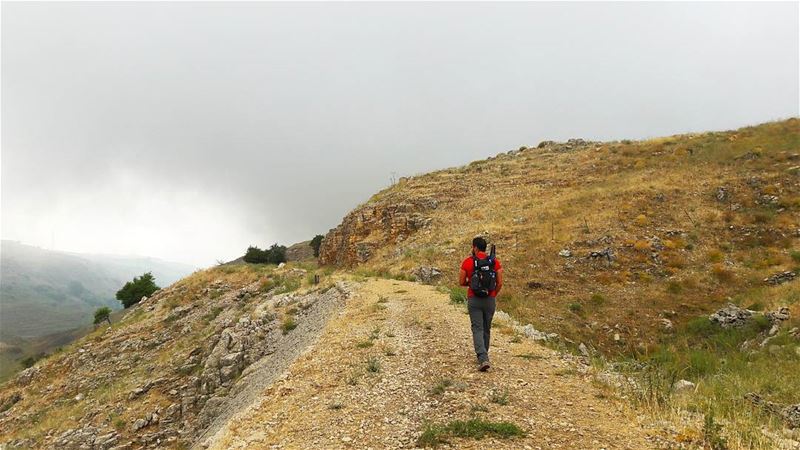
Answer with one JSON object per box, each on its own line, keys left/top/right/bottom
{"left": 192, "top": 283, "right": 351, "bottom": 448}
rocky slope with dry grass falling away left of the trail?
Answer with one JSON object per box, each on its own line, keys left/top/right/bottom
{"left": 0, "top": 265, "right": 348, "bottom": 449}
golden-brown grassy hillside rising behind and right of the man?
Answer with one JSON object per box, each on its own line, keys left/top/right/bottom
{"left": 320, "top": 119, "right": 800, "bottom": 354}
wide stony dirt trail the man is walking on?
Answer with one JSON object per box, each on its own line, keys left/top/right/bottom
{"left": 203, "top": 279, "right": 652, "bottom": 449}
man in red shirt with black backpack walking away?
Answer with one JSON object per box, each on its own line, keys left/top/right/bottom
{"left": 459, "top": 237, "right": 503, "bottom": 372}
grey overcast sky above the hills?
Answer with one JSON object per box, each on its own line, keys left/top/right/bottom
{"left": 0, "top": 2, "right": 800, "bottom": 266}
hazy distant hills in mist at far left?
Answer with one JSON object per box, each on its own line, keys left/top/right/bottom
{"left": 0, "top": 240, "right": 194, "bottom": 379}
